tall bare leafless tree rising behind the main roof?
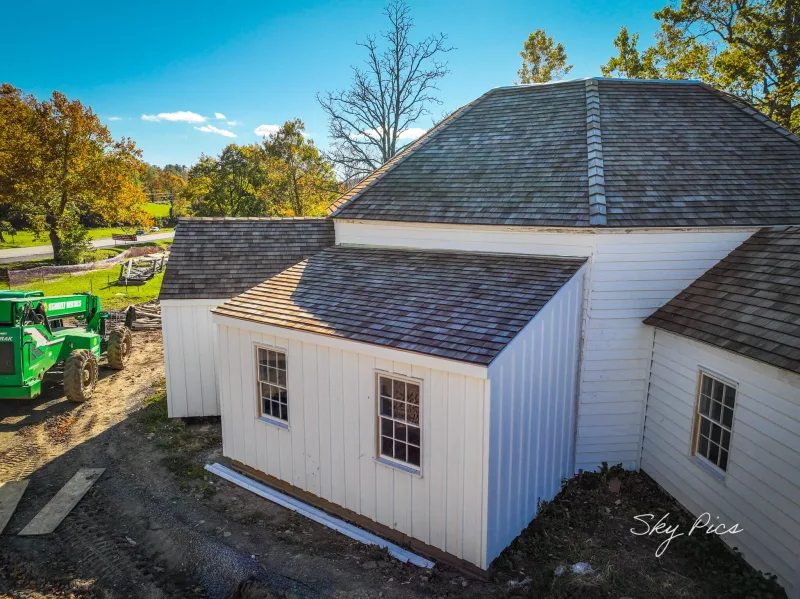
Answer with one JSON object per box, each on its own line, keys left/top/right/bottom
{"left": 317, "top": 0, "right": 452, "bottom": 179}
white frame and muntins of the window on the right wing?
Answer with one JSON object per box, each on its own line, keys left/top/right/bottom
{"left": 691, "top": 367, "right": 739, "bottom": 478}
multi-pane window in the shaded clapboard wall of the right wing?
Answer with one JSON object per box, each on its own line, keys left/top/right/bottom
{"left": 693, "top": 371, "right": 736, "bottom": 471}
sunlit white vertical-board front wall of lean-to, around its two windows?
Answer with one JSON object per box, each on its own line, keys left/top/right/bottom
{"left": 217, "top": 325, "right": 488, "bottom": 567}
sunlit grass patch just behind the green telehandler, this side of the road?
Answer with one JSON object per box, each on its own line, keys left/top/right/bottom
{"left": 14, "top": 265, "right": 164, "bottom": 310}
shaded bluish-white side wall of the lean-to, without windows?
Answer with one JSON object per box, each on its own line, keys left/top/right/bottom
{"left": 487, "top": 268, "right": 584, "bottom": 562}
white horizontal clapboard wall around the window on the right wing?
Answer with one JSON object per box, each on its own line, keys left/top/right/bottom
{"left": 641, "top": 330, "right": 800, "bottom": 597}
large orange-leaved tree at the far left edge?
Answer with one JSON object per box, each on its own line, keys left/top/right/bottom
{"left": 0, "top": 84, "right": 150, "bottom": 262}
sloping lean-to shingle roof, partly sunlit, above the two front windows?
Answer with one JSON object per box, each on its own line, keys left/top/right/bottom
{"left": 214, "top": 246, "right": 585, "bottom": 365}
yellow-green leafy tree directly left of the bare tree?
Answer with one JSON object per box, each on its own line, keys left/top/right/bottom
{"left": 263, "top": 119, "right": 340, "bottom": 216}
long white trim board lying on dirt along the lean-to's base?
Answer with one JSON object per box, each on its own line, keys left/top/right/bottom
{"left": 206, "top": 464, "right": 436, "bottom": 568}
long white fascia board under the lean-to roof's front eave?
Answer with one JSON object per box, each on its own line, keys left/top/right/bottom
{"left": 213, "top": 314, "right": 489, "bottom": 379}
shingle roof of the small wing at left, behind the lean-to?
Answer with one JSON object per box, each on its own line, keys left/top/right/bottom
{"left": 159, "top": 218, "right": 334, "bottom": 300}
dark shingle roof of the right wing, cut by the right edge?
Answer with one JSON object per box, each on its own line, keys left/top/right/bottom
{"left": 645, "top": 227, "right": 800, "bottom": 373}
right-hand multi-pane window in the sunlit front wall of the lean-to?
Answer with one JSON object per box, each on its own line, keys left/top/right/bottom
{"left": 377, "top": 374, "right": 422, "bottom": 470}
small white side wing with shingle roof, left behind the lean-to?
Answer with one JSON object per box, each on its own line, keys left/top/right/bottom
{"left": 159, "top": 218, "right": 334, "bottom": 418}
